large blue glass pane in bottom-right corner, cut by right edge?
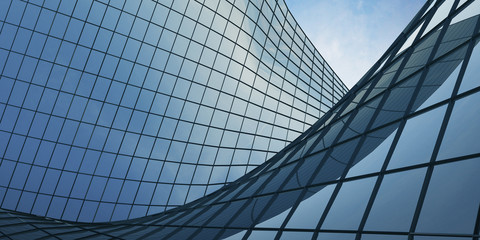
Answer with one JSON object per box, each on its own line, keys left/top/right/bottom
{"left": 416, "top": 158, "right": 480, "bottom": 234}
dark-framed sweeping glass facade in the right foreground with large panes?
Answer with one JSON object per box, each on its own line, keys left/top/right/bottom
{"left": 0, "top": 0, "right": 480, "bottom": 240}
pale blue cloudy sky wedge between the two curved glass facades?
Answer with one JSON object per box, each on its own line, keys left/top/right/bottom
{"left": 285, "top": 0, "right": 426, "bottom": 88}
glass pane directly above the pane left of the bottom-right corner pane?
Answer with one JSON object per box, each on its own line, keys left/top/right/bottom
{"left": 388, "top": 106, "right": 446, "bottom": 169}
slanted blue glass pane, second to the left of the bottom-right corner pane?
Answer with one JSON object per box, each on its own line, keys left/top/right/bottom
{"left": 322, "top": 177, "right": 376, "bottom": 230}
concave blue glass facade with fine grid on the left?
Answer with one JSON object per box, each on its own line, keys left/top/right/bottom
{"left": 0, "top": 0, "right": 347, "bottom": 222}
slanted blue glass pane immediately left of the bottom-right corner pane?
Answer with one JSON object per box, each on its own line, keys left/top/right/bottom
{"left": 362, "top": 168, "right": 426, "bottom": 231}
